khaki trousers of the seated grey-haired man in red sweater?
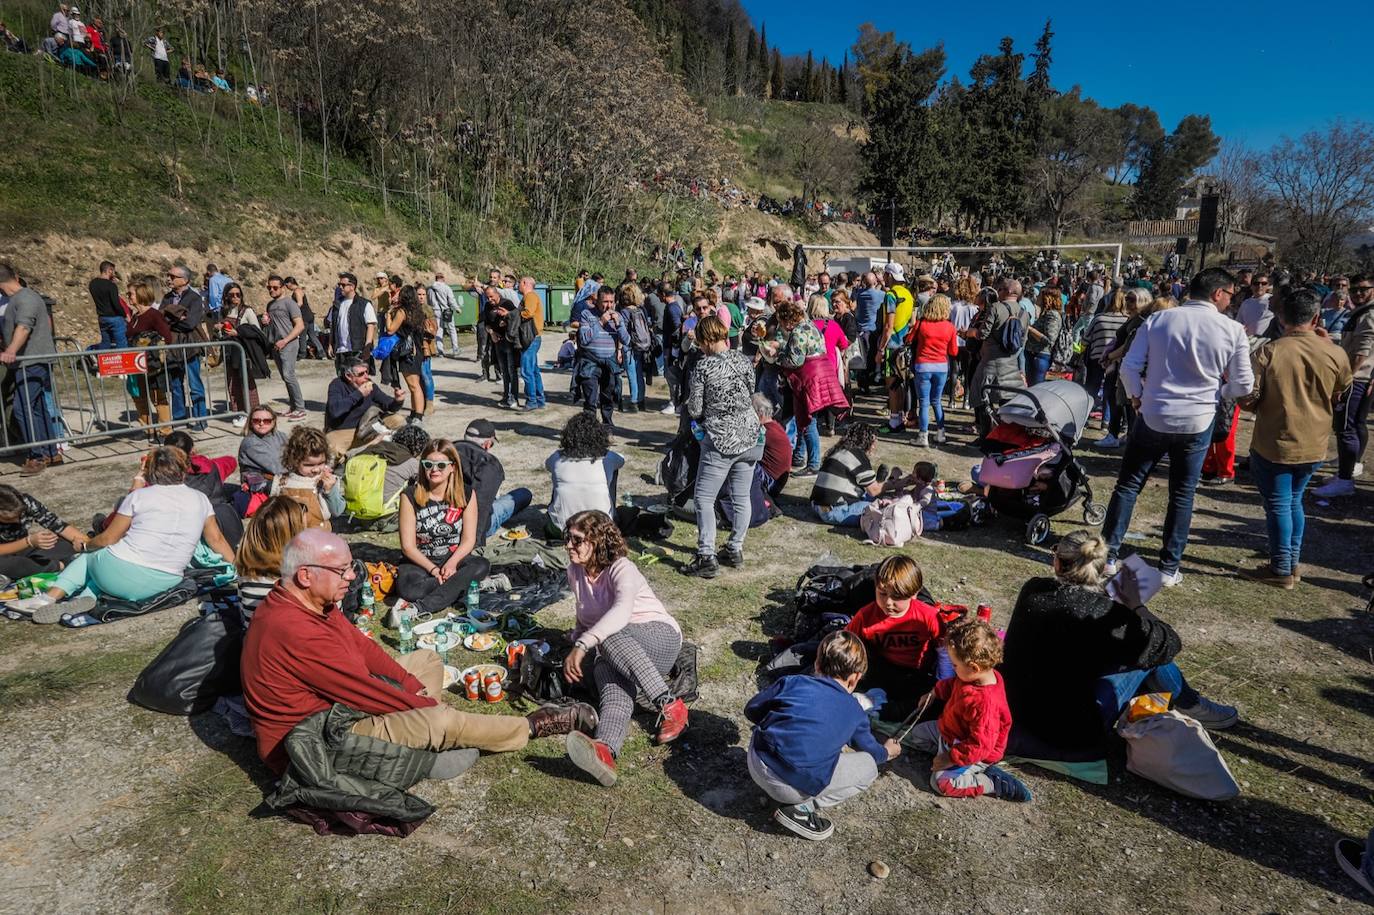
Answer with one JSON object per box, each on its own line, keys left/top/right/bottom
{"left": 353, "top": 648, "right": 529, "bottom": 753}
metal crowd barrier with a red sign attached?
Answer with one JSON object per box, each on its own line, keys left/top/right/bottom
{"left": 0, "top": 337, "right": 249, "bottom": 455}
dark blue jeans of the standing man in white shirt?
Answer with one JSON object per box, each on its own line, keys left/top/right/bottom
{"left": 1102, "top": 416, "right": 1212, "bottom": 573}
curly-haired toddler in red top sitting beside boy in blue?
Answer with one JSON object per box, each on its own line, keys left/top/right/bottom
{"left": 905, "top": 618, "right": 1031, "bottom": 801}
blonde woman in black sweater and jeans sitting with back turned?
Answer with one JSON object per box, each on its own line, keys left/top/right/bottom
{"left": 1002, "top": 530, "right": 1239, "bottom": 758}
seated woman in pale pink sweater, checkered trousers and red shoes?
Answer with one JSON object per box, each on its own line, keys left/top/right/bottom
{"left": 563, "top": 511, "right": 687, "bottom": 787}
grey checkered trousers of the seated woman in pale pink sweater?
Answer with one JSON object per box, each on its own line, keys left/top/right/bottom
{"left": 592, "top": 622, "right": 683, "bottom": 756}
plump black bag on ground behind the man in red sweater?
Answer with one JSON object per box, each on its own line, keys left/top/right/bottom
{"left": 129, "top": 610, "right": 243, "bottom": 714}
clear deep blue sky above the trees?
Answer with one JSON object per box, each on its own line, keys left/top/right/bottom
{"left": 742, "top": 0, "right": 1374, "bottom": 148}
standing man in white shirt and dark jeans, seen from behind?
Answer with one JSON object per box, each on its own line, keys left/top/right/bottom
{"left": 1102, "top": 267, "right": 1254, "bottom": 588}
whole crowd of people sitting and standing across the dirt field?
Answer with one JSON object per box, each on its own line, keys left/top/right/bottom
{"left": 0, "top": 240, "right": 1374, "bottom": 872}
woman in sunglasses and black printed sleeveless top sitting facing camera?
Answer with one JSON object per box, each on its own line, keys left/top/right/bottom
{"left": 396, "top": 438, "right": 491, "bottom": 614}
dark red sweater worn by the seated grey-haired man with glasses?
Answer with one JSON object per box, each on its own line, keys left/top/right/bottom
{"left": 240, "top": 584, "right": 436, "bottom": 773}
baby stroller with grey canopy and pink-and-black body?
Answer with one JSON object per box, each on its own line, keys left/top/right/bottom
{"left": 974, "top": 381, "right": 1106, "bottom": 544}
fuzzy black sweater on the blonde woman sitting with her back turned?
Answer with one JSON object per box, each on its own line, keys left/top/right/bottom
{"left": 1002, "top": 578, "right": 1183, "bottom": 749}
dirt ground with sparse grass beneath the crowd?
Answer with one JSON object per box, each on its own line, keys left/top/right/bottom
{"left": 0, "top": 350, "right": 1374, "bottom": 914}
